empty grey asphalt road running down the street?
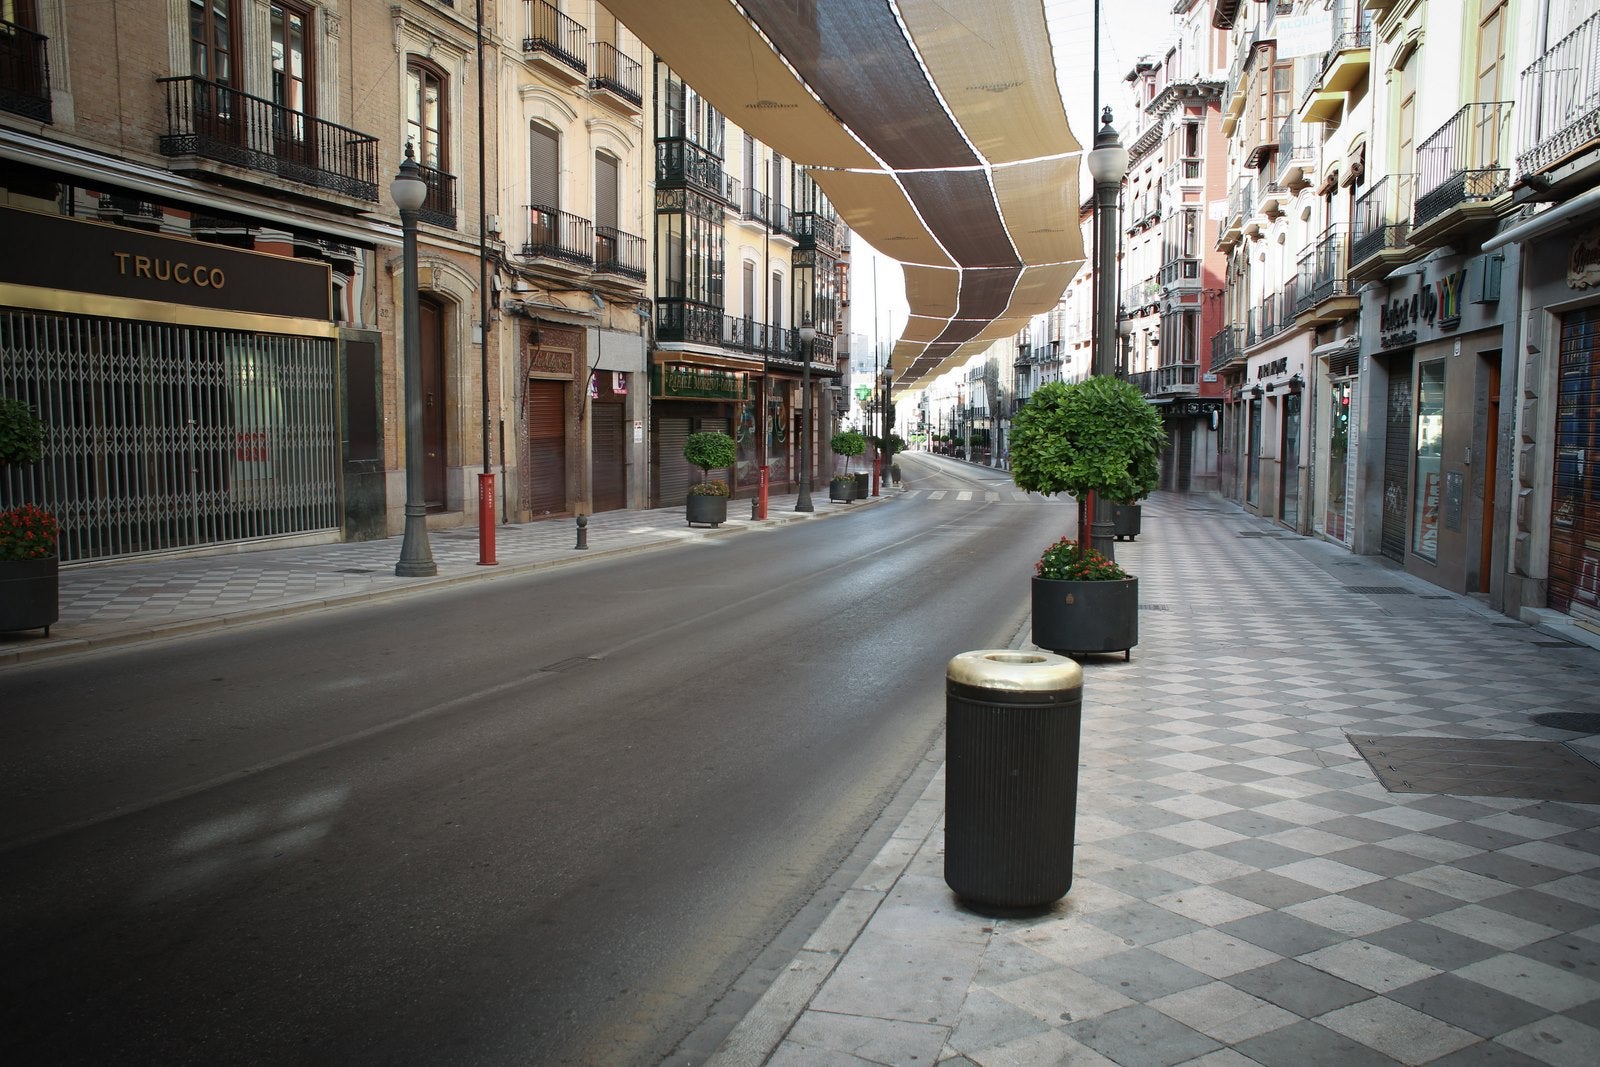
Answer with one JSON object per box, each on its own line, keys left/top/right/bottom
{"left": 0, "top": 456, "right": 1072, "bottom": 1064}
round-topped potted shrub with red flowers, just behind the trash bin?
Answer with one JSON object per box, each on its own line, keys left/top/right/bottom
{"left": 1011, "top": 378, "right": 1166, "bottom": 654}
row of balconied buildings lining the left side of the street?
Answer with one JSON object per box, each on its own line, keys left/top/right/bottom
{"left": 0, "top": 0, "right": 848, "bottom": 561}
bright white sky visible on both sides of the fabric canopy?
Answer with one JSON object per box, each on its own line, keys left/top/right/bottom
{"left": 850, "top": 0, "right": 1173, "bottom": 375}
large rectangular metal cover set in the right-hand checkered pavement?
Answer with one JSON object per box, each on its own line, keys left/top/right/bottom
{"left": 1346, "top": 734, "right": 1600, "bottom": 805}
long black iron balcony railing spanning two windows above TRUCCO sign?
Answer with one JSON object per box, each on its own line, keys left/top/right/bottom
{"left": 157, "top": 77, "right": 378, "bottom": 203}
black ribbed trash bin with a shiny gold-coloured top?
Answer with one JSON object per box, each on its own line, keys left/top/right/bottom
{"left": 944, "top": 649, "right": 1083, "bottom": 907}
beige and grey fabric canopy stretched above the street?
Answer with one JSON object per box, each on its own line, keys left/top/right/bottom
{"left": 606, "top": 0, "right": 1083, "bottom": 392}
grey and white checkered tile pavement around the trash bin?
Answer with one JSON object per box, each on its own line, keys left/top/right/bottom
{"left": 732, "top": 496, "right": 1600, "bottom": 1067}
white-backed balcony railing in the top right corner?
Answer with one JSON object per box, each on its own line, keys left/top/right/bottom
{"left": 1517, "top": 13, "right": 1600, "bottom": 176}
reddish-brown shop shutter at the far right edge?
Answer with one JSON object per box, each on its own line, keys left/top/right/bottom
{"left": 1549, "top": 307, "right": 1600, "bottom": 625}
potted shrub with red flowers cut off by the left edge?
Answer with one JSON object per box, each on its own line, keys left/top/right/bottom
{"left": 0, "top": 398, "right": 61, "bottom": 637}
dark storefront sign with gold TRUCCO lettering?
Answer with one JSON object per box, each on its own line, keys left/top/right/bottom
{"left": 0, "top": 201, "right": 333, "bottom": 322}
